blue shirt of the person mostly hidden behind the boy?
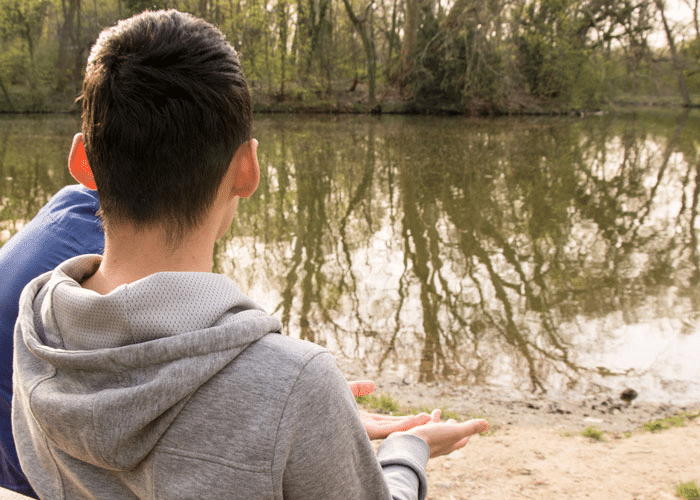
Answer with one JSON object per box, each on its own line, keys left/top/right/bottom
{"left": 0, "top": 186, "right": 104, "bottom": 497}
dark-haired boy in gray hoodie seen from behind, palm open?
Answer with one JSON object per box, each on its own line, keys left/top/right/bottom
{"left": 12, "top": 11, "right": 486, "bottom": 500}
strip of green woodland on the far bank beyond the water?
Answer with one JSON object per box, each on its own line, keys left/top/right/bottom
{"left": 0, "top": 0, "right": 700, "bottom": 114}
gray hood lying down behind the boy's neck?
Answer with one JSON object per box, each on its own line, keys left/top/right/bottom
{"left": 14, "top": 255, "right": 281, "bottom": 470}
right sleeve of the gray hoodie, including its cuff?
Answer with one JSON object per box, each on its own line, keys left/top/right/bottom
{"left": 273, "top": 352, "right": 430, "bottom": 500}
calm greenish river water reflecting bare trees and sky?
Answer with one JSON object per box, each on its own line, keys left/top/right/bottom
{"left": 0, "top": 111, "right": 700, "bottom": 404}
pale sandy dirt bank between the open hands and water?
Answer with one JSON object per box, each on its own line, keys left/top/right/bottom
{"left": 341, "top": 360, "right": 700, "bottom": 500}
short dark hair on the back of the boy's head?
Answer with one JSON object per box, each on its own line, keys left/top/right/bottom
{"left": 79, "top": 10, "right": 252, "bottom": 244}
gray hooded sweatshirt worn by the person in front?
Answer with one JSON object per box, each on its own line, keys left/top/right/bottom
{"left": 12, "top": 255, "right": 429, "bottom": 500}
